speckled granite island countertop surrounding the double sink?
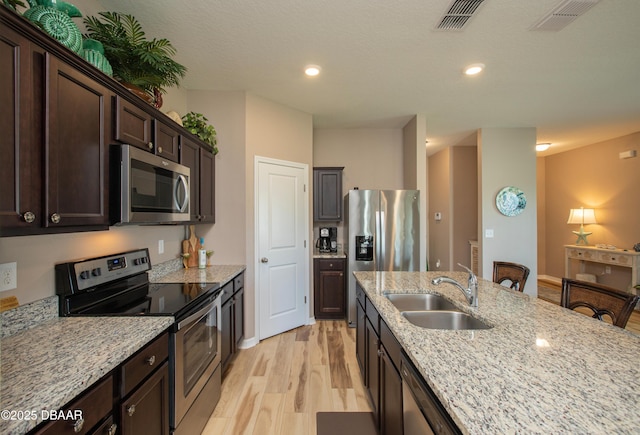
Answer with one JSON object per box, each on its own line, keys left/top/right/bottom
{"left": 354, "top": 272, "right": 640, "bottom": 434}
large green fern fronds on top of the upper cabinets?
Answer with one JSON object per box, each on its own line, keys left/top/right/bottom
{"left": 84, "top": 12, "right": 187, "bottom": 107}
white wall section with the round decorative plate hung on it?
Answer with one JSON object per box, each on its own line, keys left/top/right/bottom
{"left": 478, "top": 128, "right": 538, "bottom": 295}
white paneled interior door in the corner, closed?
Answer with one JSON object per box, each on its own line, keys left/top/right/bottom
{"left": 256, "top": 158, "right": 309, "bottom": 339}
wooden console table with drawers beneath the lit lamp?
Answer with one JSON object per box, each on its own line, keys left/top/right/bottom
{"left": 564, "top": 245, "right": 640, "bottom": 287}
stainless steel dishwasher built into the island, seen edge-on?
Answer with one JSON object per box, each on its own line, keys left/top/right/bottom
{"left": 400, "top": 352, "right": 461, "bottom": 435}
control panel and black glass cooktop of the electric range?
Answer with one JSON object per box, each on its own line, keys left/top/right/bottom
{"left": 55, "top": 248, "right": 220, "bottom": 320}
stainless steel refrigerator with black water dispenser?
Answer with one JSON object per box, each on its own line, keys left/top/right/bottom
{"left": 344, "top": 190, "right": 420, "bottom": 327}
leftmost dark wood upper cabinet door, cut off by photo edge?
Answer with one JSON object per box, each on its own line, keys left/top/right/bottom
{"left": 0, "top": 25, "right": 44, "bottom": 235}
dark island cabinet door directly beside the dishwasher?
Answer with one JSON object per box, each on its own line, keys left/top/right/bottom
{"left": 380, "top": 346, "right": 403, "bottom": 435}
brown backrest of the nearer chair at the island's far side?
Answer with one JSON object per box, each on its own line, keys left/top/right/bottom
{"left": 560, "top": 278, "right": 639, "bottom": 328}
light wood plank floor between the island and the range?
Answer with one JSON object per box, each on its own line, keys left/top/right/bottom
{"left": 202, "top": 320, "right": 371, "bottom": 435}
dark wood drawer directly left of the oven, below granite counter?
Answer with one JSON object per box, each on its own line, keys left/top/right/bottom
{"left": 120, "top": 332, "right": 169, "bottom": 397}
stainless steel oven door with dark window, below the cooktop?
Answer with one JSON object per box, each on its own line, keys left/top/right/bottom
{"left": 173, "top": 293, "right": 222, "bottom": 427}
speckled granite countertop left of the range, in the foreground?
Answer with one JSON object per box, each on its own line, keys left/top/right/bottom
{"left": 0, "top": 316, "right": 174, "bottom": 434}
